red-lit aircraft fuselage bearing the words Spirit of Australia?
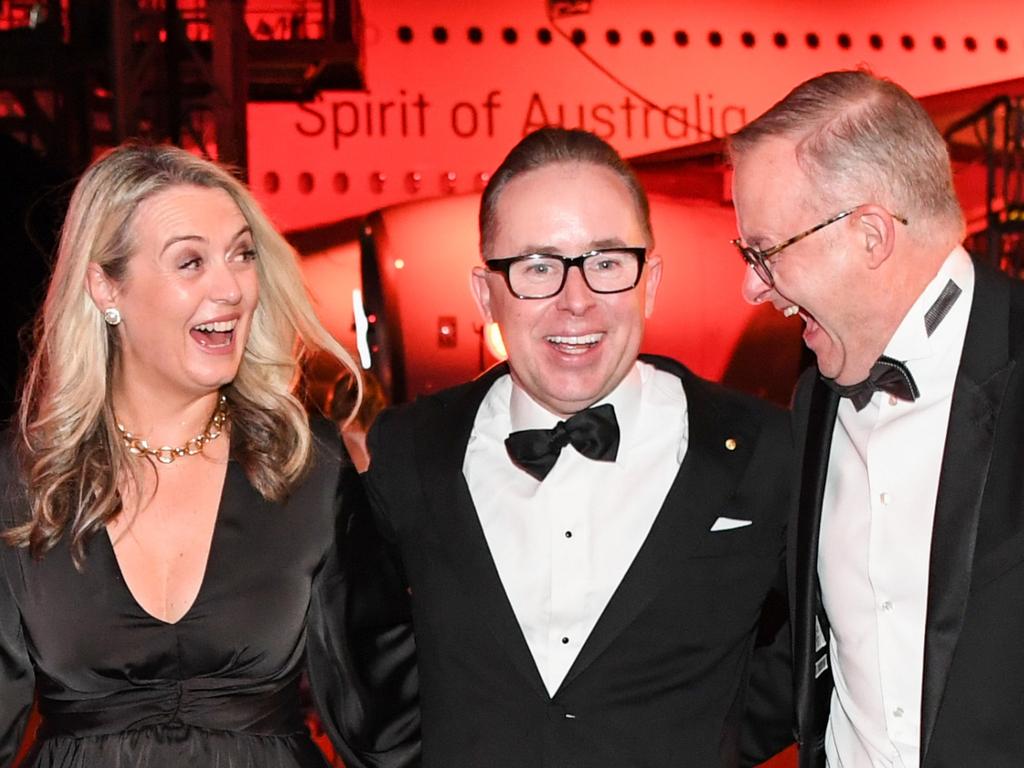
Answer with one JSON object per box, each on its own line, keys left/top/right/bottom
{"left": 248, "top": 0, "right": 1024, "bottom": 229}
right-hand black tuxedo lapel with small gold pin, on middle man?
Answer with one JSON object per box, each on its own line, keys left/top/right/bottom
{"left": 560, "top": 364, "right": 758, "bottom": 688}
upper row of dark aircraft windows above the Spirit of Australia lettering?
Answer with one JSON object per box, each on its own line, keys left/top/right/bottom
{"left": 389, "top": 25, "right": 1010, "bottom": 53}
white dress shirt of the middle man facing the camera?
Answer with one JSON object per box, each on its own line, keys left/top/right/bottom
{"left": 463, "top": 362, "right": 687, "bottom": 695}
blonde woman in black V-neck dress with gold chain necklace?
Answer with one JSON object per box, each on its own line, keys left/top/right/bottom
{"left": 0, "top": 144, "right": 411, "bottom": 768}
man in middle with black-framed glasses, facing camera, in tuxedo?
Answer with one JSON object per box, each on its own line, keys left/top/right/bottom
{"left": 331, "top": 123, "right": 792, "bottom": 768}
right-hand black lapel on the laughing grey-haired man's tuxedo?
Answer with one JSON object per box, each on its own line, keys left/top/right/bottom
{"left": 921, "top": 264, "right": 1015, "bottom": 765}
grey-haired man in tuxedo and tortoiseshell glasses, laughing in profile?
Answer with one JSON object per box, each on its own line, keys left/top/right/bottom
{"left": 730, "top": 72, "right": 1024, "bottom": 768}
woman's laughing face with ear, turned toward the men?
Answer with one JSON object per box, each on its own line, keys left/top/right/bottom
{"left": 89, "top": 186, "right": 259, "bottom": 398}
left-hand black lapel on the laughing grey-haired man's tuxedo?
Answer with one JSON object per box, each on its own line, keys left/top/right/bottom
{"left": 790, "top": 376, "right": 840, "bottom": 740}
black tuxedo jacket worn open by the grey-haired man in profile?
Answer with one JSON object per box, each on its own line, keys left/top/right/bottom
{"left": 788, "top": 264, "right": 1024, "bottom": 768}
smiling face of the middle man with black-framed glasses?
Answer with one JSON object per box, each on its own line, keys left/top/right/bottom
{"left": 473, "top": 158, "right": 662, "bottom": 416}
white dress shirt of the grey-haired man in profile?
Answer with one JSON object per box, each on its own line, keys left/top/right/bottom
{"left": 818, "top": 247, "right": 974, "bottom": 768}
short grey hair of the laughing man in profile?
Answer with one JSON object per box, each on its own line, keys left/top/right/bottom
{"left": 728, "top": 70, "right": 964, "bottom": 233}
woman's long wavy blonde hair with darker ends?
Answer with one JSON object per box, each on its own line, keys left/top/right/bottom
{"left": 4, "top": 142, "right": 358, "bottom": 567}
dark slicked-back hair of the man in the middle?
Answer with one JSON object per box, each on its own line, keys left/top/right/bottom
{"left": 480, "top": 127, "right": 654, "bottom": 259}
